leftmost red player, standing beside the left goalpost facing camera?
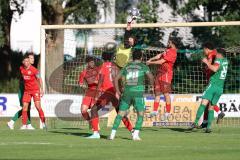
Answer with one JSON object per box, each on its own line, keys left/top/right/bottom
{"left": 20, "top": 55, "right": 47, "bottom": 129}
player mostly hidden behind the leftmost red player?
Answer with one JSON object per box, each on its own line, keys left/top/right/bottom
{"left": 7, "top": 52, "right": 35, "bottom": 130}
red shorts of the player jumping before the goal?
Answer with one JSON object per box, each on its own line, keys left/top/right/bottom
{"left": 154, "top": 74, "right": 172, "bottom": 94}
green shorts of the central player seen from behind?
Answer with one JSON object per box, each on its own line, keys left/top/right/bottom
{"left": 119, "top": 91, "right": 145, "bottom": 112}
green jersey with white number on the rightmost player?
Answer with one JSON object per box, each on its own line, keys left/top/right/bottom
{"left": 210, "top": 58, "right": 228, "bottom": 88}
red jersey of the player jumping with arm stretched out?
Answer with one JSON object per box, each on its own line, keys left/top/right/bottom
{"left": 159, "top": 48, "right": 177, "bottom": 75}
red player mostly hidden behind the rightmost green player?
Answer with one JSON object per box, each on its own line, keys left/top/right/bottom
{"left": 200, "top": 42, "right": 225, "bottom": 128}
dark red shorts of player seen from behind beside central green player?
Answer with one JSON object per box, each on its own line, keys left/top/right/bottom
{"left": 97, "top": 88, "right": 119, "bottom": 107}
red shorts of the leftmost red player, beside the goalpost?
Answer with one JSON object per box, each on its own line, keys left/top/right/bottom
{"left": 22, "top": 90, "right": 41, "bottom": 103}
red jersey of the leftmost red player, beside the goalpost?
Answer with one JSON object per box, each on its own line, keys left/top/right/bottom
{"left": 20, "top": 66, "right": 40, "bottom": 91}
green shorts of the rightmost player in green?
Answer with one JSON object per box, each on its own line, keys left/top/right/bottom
{"left": 202, "top": 84, "right": 223, "bottom": 105}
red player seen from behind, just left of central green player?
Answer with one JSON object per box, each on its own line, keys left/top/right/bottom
{"left": 86, "top": 51, "right": 133, "bottom": 139}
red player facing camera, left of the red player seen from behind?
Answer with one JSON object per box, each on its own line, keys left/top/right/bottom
{"left": 79, "top": 57, "right": 99, "bottom": 125}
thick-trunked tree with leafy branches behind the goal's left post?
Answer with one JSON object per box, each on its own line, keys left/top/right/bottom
{"left": 41, "top": 0, "right": 97, "bottom": 92}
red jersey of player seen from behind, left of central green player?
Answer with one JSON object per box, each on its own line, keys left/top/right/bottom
{"left": 100, "top": 62, "right": 118, "bottom": 91}
